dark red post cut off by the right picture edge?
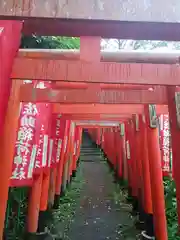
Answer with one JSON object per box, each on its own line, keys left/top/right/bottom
{"left": 167, "top": 87, "right": 180, "bottom": 229}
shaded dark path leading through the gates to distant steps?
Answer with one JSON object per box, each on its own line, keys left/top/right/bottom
{"left": 68, "top": 135, "right": 138, "bottom": 240}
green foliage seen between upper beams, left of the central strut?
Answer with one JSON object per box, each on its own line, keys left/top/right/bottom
{"left": 21, "top": 35, "right": 80, "bottom": 49}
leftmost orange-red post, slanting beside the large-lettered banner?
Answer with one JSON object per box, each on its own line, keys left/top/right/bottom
{"left": 0, "top": 80, "right": 22, "bottom": 239}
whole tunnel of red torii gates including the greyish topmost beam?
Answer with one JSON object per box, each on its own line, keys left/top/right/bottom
{"left": 0, "top": 0, "right": 180, "bottom": 240}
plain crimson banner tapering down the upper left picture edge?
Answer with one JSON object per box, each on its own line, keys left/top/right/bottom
{"left": 0, "top": 20, "right": 22, "bottom": 135}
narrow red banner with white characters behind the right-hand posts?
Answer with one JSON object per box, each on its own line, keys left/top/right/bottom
{"left": 160, "top": 115, "right": 170, "bottom": 175}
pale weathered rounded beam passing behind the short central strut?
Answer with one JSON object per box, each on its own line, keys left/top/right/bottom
{"left": 17, "top": 48, "right": 180, "bottom": 64}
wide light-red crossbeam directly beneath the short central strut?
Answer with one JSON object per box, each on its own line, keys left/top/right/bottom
{"left": 11, "top": 59, "right": 180, "bottom": 85}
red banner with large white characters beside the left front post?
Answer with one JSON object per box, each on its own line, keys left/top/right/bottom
{"left": 10, "top": 103, "right": 38, "bottom": 186}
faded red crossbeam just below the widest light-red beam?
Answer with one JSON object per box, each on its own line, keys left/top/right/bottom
{"left": 20, "top": 83, "right": 167, "bottom": 104}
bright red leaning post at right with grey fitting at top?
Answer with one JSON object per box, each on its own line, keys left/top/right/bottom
{"left": 145, "top": 105, "right": 168, "bottom": 240}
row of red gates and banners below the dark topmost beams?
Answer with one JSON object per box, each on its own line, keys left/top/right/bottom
{"left": 0, "top": 21, "right": 180, "bottom": 240}
